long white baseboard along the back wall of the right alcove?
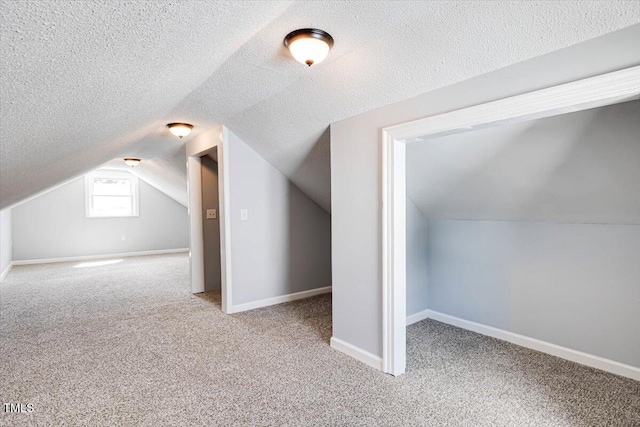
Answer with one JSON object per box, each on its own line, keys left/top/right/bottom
{"left": 424, "top": 310, "right": 640, "bottom": 381}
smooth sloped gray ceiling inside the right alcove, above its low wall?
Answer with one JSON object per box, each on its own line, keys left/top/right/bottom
{"left": 407, "top": 101, "right": 640, "bottom": 224}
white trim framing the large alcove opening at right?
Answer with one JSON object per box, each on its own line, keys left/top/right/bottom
{"left": 381, "top": 66, "right": 640, "bottom": 375}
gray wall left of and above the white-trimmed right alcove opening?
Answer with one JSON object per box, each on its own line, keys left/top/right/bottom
{"left": 331, "top": 26, "right": 640, "bottom": 356}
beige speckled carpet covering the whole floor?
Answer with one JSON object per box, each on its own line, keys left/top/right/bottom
{"left": 0, "top": 254, "right": 640, "bottom": 427}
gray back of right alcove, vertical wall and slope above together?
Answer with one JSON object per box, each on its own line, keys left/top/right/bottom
{"left": 418, "top": 101, "right": 640, "bottom": 367}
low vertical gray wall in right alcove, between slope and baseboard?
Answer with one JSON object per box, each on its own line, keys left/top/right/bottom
{"left": 429, "top": 219, "right": 640, "bottom": 367}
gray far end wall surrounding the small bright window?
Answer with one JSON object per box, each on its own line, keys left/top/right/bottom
{"left": 13, "top": 177, "right": 189, "bottom": 261}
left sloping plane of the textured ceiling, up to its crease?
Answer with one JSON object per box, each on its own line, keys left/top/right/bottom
{"left": 0, "top": 1, "right": 289, "bottom": 207}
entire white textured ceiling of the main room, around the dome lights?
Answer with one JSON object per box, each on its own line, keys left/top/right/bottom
{"left": 0, "top": 1, "right": 640, "bottom": 210}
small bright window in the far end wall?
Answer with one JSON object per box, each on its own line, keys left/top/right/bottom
{"left": 85, "top": 170, "right": 139, "bottom": 218}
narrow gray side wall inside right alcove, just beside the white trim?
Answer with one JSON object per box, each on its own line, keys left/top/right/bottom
{"left": 407, "top": 197, "right": 429, "bottom": 316}
